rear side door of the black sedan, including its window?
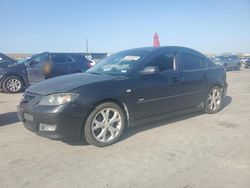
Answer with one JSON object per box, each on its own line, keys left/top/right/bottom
{"left": 180, "top": 52, "right": 209, "bottom": 109}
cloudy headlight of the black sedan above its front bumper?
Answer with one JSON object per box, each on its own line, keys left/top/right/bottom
{"left": 39, "top": 93, "right": 79, "bottom": 105}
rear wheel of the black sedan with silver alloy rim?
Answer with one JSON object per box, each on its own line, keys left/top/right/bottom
{"left": 204, "top": 86, "right": 223, "bottom": 114}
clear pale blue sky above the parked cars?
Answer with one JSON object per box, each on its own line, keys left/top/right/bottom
{"left": 0, "top": 0, "right": 250, "bottom": 53}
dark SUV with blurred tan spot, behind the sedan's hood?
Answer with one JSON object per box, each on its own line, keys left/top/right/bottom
{"left": 0, "top": 52, "right": 91, "bottom": 93}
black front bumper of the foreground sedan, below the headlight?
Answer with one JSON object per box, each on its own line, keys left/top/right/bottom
{"left": 17, "top": 103, "right": 87, "bottom": 139}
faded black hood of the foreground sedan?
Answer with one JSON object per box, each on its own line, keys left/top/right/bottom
{"left": 26, "top": 73, "right": 114, "bottom": 95}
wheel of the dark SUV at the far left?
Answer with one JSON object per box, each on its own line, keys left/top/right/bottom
{"left": 3, "top": 76, "right": 24, "bottom": 93}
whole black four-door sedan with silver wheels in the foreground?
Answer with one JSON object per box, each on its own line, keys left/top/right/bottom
{"left": 18, "top": 47, "right": 227, "bottom": 147}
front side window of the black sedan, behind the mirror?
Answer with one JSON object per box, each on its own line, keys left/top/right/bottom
{"left": 148, "top": 54, "right": 175, "bottom": 72}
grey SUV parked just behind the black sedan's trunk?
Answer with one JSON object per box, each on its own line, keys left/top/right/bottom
{"left": 213, "top": 55, "right": 241, "bottom": 70}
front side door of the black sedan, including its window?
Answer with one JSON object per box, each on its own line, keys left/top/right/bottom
{"left": 133, "top": 53, "right": 182, "bottom": 120}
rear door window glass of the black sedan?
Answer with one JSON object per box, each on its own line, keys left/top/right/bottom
{"left": 181, "top": 54, "right": 202, "bottom": 71}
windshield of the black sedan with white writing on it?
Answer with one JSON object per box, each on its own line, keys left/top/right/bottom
{"left": 87, "top": 50, "right": 150, "bottom": 75}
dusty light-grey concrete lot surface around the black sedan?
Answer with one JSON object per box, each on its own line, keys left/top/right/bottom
{"left": 0, "top": 69, "right": 250, "bottom": 188}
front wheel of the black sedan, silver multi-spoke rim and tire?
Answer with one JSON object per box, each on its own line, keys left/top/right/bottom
{"left": 84, "top": 102, "right": 125, "bottom": 147}
